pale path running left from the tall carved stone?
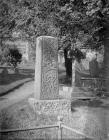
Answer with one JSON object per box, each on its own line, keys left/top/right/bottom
{"left": 0, "top": 81, "right": 34, "bottom": 110}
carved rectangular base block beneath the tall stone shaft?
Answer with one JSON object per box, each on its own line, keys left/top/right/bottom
{"left": 29, "top": 98, "right": 71, "bottom": 115}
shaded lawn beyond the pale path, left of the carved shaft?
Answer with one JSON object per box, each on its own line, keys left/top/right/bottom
{"left": 0, "top": 66, "right": 35, "bottom": 96}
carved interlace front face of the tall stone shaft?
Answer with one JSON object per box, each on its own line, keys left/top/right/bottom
{"left": 41, "top": 38, "right": 58, "bottom": 99}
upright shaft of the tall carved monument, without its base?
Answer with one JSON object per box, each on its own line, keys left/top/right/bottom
{"left": 35, "top": 36, "right": 59, "bottom": 100}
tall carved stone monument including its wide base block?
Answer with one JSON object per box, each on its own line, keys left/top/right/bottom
{"left": 28, "top": 36, "right": 71, "bottom": 130}
